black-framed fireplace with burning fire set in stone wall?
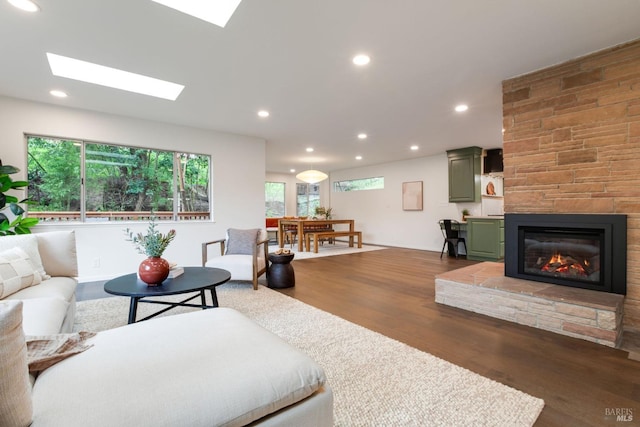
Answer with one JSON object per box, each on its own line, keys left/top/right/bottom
{"left": 504, "top": 214, "right": 627, "bottom": 295}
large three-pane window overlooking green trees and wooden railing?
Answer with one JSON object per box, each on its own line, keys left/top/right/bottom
{"left": 27, "top": 136, "right": 211, "bottom": 222}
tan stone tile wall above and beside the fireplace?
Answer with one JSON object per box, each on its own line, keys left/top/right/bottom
{"left": 503, "top": 40, "right": 640, "bottom": 329}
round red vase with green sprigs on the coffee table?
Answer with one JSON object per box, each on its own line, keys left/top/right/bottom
{"left": 125, "top": 215, "right": 176, "bottom": 286}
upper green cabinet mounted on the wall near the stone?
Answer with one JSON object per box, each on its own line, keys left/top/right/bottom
{"left": 447, "top": 147, "right": 482, "bottom": 203}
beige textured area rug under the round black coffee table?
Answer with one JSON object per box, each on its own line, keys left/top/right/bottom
{"left": 75, "top": 283, "right": 544, "bottom": 427}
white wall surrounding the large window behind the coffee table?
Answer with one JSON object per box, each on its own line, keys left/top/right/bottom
{"left": 0, "top": 97, "right": 266, "bottom": 281}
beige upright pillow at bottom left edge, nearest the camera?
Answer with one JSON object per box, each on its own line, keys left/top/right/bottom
{"left": 0, "top": 300, "right": 33, "bottom": 427}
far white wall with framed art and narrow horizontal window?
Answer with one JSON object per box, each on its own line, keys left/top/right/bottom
{"left": 327, "top": 153, "right": 481, "bottom": 252}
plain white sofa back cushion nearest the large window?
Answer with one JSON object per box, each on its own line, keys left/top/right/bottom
{"left": 35, "top": 230, "right": 78, "bottom": 277}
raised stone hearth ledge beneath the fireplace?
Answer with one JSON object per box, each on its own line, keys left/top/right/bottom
{"left": 436, "top": 262, "right": 624, "bottom": 348}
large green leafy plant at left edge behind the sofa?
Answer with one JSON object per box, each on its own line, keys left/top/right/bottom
{"left": 0, "top": 160, "right": 39, "bottom": 236}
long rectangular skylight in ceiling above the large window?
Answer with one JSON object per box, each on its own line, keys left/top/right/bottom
{"left": 47, "top": 52, "right": 184, "bottom": 101}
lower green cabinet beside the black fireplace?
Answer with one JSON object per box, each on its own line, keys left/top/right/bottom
{"left": 467, "top": 217, "right": 504, "bottom": 261}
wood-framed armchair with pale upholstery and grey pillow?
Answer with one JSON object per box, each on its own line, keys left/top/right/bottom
{"left": 202, "top": 228, "right": 269, "bottom": 290}
